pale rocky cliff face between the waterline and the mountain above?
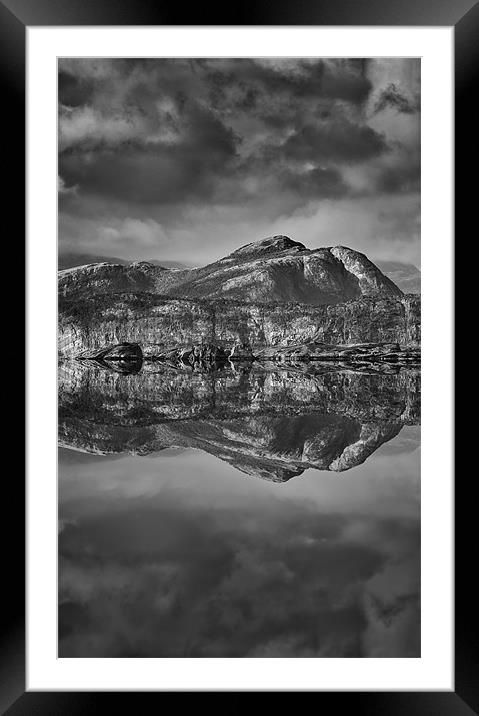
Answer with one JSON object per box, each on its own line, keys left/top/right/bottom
{"left": 58, "top": 293, "right": 420, "bottom": 356}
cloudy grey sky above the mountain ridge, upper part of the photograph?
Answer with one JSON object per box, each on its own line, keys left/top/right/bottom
{"left": 58, "top": 59, "right": 420, "bottom": 265}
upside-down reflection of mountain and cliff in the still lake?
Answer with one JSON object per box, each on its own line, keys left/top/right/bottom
{"left": 59, "top": 361, "right": 420, "bottom": 482}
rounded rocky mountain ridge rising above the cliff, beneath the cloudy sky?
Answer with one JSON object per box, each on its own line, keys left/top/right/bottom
{"left": 58, "top": 236, "right": 403, "bottom": 305}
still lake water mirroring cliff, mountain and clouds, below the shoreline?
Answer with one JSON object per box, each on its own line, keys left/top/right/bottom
{"left": 59, "top": 364, "right": 420, "bottom": 657}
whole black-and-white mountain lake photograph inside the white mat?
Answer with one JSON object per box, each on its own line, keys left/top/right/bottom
{"left": 58, "top": 57, "right": 421, "bottom": 658}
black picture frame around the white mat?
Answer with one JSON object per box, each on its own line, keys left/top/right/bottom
{"left": 4, "top": 0, "right": 468, "bottom": 716}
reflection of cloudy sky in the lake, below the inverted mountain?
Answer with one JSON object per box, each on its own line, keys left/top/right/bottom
{"left": 59, "top": 442, "right": 420, "bottom": 657}
